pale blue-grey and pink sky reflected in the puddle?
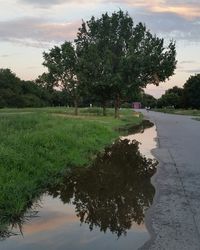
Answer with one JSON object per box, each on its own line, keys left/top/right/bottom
{"left": 0, "top": 124, "right": 156, "bottom": 250}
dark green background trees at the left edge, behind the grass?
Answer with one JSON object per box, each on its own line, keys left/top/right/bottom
{"left": 0, "top": 69, "right": 69, "bottom": 108}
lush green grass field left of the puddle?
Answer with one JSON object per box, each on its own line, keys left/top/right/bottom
{"left": 0, "top": 108, "right": 142, "bottom": 224}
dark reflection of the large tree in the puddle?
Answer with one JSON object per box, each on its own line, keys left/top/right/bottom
{"left": 49, "top": 140, "right": 156, "bottom": 236}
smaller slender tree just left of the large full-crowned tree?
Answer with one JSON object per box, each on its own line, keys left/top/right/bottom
{"left": 42, "top": 42, "right": 79, "bottom": 115}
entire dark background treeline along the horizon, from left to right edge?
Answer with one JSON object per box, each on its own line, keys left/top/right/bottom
{"left": 0, "top": 69, "right": 200, "bottom": 109}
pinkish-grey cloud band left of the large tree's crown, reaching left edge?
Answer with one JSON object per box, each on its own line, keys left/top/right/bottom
{"left": 0, "top": 18, "right": 81, "bottom": 47}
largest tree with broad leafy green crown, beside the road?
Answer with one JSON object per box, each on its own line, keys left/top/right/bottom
{"left": 75, "top": 10, "right": 176, "bottom": 117}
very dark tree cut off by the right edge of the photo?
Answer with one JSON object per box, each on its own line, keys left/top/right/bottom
{"left": 183, "top": 74, "right": 200, "bottom": 108}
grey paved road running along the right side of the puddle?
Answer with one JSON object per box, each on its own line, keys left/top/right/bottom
{"left": 138, "top": 110, "right": 200, "bottom": 250}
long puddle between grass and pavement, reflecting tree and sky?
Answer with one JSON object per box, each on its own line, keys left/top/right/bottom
{"left": 0, "top": 121, "right": 156, "bottom": 250}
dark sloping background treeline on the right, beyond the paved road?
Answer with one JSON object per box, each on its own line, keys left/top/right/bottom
{"left": 156, "top": 74, "right": 200, "bottom": 109}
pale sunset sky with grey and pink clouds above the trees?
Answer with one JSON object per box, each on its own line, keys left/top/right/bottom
{"left": 0, "top": 0, "right": 200, "bottom": 98}
